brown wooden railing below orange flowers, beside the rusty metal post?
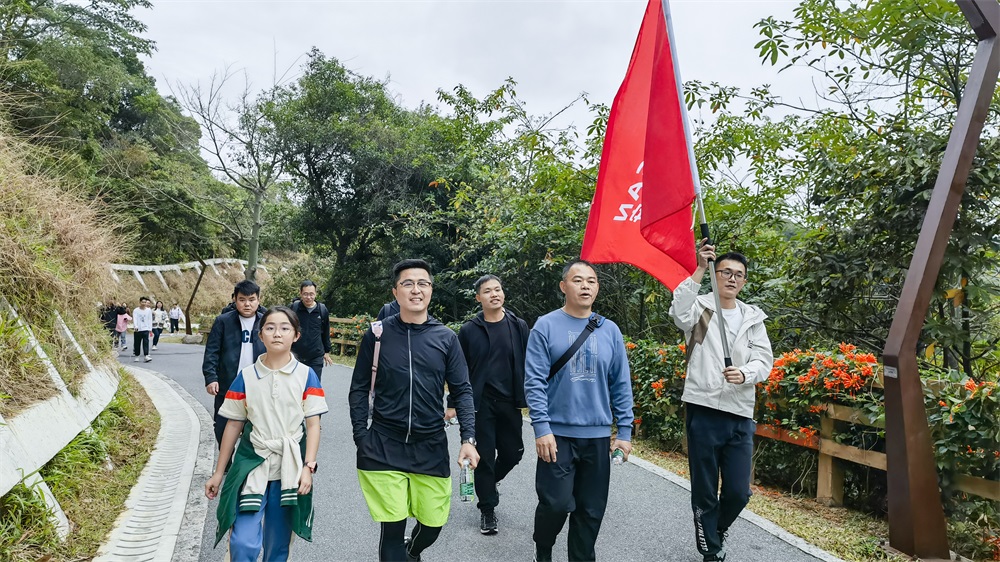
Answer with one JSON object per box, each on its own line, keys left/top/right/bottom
{"left": 757, "top": 404, "right": 1000, "bottom": 505}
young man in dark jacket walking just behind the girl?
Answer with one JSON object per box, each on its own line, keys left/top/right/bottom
{"left": 201, "top": 280, "right": 265, "bottom": 443}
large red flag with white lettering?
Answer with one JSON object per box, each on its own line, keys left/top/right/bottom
{"left": 580, "top": 0, "right": 697, "bottom": 290}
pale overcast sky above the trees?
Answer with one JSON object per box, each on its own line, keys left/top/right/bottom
{"left": 137, "top": 0, "right": 811, "bottom": 129}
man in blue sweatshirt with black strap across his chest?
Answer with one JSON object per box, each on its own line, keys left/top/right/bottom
{"left": 524, "top": 260, "right": 633, "bottom": 562}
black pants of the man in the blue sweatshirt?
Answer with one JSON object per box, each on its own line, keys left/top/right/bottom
{"left": 532, "top": 435, "right": 611, "bottom": 562}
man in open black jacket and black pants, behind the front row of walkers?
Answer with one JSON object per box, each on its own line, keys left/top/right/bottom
{"left": 446, "top": 275, "right": 528, "bottom": 535}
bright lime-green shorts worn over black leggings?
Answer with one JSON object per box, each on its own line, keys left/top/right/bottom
{"left": 358, "top": 470, "right": 451, "bottom": 527}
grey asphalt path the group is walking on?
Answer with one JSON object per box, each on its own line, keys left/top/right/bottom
{"left": 121, "top": 342, "right": 820, "bottom": 562}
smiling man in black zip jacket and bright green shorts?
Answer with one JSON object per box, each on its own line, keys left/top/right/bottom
{"left": 348, "top": 260, "right": 479, "bottom": 561}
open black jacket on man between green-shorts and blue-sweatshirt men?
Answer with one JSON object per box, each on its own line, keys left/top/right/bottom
{"left": 448, "top": 309, "right": 529, "bottom": 411}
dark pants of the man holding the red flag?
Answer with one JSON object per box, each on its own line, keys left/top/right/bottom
{"left": 685, "top": 404, "right": 757, "bottom": 555}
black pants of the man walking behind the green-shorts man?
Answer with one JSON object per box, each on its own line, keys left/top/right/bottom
{"left": 476, "top": 396, "right": 524, "bottom": 509}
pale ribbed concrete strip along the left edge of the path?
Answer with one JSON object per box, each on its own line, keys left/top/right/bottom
{"left": 94, "top": 368, "right": 214, "bottom": 562}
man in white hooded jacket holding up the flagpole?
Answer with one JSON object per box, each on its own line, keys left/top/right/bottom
{"left": 670, "top": 239, "right": 774, "bottom": 562}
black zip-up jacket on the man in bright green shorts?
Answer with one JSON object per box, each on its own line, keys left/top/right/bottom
{"left": 347, "top": 315, "right": 476, "bottom": 443}
